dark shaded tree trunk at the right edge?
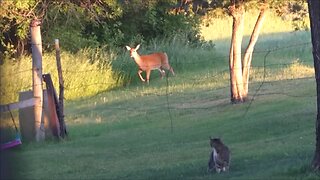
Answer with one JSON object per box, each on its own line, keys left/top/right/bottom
{"left": 308, "top": 0, "right": 320, "bottom": 170}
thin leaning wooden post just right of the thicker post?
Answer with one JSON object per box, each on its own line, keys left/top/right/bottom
{"left": 54, "top": 39, "right": 67, "bottom": 137}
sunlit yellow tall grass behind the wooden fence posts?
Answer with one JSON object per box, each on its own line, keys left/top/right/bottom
{"left": 0, "top": 50, "right": 123, "bottom": 104}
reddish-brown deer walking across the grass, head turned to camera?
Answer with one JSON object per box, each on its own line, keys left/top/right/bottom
{"left": 126, "top": 44, "right": 174, "bottom": 83}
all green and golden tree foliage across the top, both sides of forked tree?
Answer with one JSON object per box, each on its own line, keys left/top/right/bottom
{"left": 0, "top": 0, "right": 308, "bottom": 60}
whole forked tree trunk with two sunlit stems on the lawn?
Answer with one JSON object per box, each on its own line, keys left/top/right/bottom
{"left": 229, "top": 0, "right": 268, "bottom": 103}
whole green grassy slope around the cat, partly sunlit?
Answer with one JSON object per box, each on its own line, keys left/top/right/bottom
{"left": 5, "top": 11, "right": 318, "bottom": 179}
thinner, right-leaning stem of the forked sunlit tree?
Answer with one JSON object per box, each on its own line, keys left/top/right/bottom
{"left": 242, "top": 3, "right": 268, "bottom": 95}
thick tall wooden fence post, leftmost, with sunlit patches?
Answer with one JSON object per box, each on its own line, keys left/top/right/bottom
{"left": 30, "top": 19, "right": 45, "bottom": 141}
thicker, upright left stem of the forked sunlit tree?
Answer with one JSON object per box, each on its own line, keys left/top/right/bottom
{"left": 229, "top": 4, "right": 244, "bottom": 103}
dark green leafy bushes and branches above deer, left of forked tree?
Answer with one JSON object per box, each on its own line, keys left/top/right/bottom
{"left": 0, "top": 0, "right": 199, "bottom": 57}
